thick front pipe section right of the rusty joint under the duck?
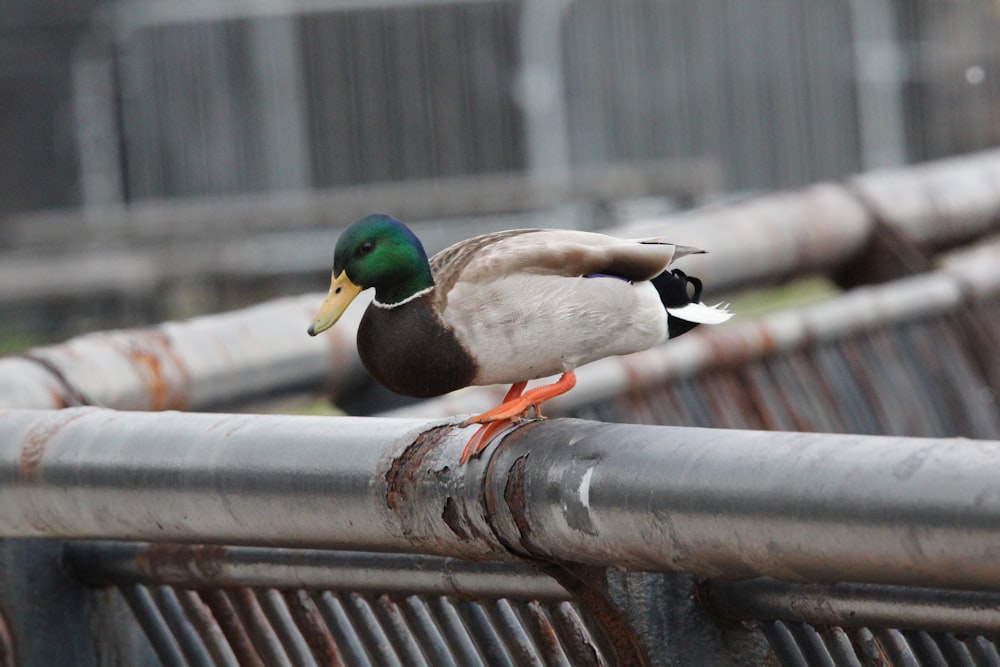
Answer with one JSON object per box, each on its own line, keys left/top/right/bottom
{"left": 487, "top": 420, "right": 1000, "bottom": 590}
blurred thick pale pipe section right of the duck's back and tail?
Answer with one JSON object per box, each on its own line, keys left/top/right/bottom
{"left": 613, "top": 149, "right": 1000, "bottom": 291}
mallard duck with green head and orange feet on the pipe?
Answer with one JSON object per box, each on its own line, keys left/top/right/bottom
{"left": 308, "top": 214, "right": 731, "bottom": 464}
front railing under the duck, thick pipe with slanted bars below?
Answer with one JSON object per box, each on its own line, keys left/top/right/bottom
{"left": 0, "top": 408, "right": 1000, "bottom": 665}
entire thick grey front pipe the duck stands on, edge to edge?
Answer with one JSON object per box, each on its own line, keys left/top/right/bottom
{"left": 0, "top": 409, "right": 1000, "bottom": 590}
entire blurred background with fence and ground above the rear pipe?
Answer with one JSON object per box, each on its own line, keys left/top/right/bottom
{"left": 0, "top": 0, "right": 1000, "bottom": 338}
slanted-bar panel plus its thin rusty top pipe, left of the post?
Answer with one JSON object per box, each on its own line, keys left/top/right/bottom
{"left": 65, "top": 542, "right": 610, "bottom": 666}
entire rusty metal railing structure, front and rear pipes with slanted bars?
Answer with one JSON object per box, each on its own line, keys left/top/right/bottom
{"left": 0, "top": 149, "right": 1000, "bottom": 667}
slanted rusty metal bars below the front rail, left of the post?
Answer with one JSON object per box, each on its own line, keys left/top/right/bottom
{"left": 111, "top": 584, "right": 610, "bottom": 666}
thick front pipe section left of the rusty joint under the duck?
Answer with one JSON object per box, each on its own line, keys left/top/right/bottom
{"left": 0, "top": 408, "right": 505, "bottom": 557}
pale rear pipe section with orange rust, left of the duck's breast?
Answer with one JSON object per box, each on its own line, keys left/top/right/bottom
{"left": 0, "top": 295, "right": 364, "bottom": 410}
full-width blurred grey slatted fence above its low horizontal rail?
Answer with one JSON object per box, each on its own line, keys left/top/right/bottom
{"left": 0, "top": 0, "right": 1000, "bottom": 216}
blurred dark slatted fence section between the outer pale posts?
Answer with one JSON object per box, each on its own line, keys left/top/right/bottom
{"left": 92, "top": 0, "right": 852, "bottom": 203}
